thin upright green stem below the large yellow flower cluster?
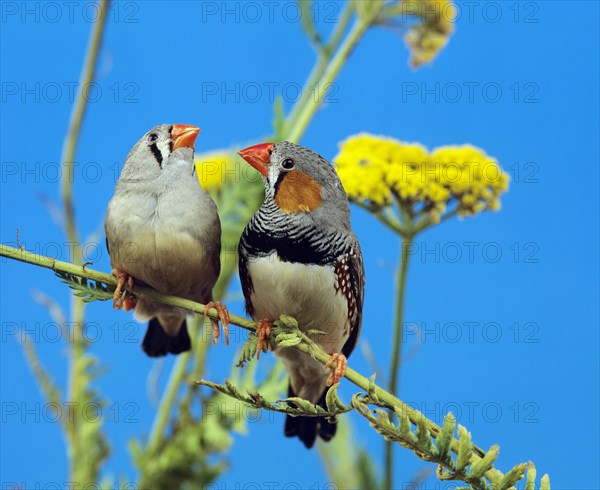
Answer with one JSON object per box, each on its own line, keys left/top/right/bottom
{"left": 385, "top": 235, "right": 413, "bottom": 488}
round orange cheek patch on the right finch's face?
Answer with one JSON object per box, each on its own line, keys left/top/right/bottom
{"left": 275, "top": 170, "right": 323, "bottom": 213}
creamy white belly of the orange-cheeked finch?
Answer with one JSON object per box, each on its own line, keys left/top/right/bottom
{"left": 248, "top": 253, "right": 349, "bottom": 354}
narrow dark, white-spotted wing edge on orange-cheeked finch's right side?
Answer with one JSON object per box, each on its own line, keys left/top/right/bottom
{"left": 342, "top": 241, "right": 365, "bottom": 357}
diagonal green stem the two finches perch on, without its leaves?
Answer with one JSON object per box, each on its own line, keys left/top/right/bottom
{"left": 0, "top": 245, "right": 496, "bottom": 468}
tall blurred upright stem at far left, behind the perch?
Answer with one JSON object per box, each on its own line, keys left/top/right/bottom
{"left": 61, "top": 0, "right": 109, "bottom": 484}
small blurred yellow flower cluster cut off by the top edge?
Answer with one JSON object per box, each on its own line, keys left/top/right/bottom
{"left": 402, "top": 0, "right": 456, "bottom": 68}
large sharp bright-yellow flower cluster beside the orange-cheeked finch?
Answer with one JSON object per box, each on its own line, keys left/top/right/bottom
{"left": 335, "top": 134, "right": 508, "bottom": 222}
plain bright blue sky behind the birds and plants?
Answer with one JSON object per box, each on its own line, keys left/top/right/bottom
{"left": 0, "top": 1, "right": 600, "bottom": 488}
